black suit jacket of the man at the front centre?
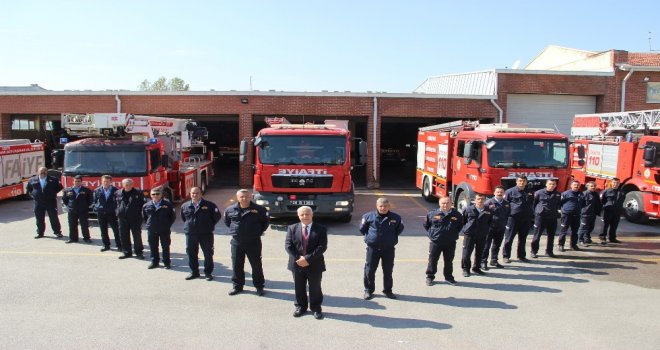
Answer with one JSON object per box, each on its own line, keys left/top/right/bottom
{"left": 284, "top": 223, "right": 328, "bottom": 272}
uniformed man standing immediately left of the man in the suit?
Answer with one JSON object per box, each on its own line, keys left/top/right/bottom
{"left": 225, "top": 189, "right": 270, "bottom": 296}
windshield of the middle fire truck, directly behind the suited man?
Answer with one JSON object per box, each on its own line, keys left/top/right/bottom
{"left": 258, "top": 135, "right": 348, "bottom": 165}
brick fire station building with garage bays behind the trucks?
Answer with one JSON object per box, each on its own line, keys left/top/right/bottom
{"left": 0, "top": 46, "right": 660, "bottom": 188}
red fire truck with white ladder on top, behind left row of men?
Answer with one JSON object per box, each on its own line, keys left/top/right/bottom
{"left": 56, "top": 113, "right": 213, "bottom": 200}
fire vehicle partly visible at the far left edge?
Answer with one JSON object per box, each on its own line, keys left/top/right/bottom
{"left": 0, "top": 139, "right": 45, "bottom": 200}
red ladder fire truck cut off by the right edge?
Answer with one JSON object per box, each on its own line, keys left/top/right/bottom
{"left": 571, "top": 109, "right": 660, "bottom": 223}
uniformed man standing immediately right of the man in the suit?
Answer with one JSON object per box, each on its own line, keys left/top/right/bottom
{"left": 360, "top": 198, "right": 403, "bottom": 300}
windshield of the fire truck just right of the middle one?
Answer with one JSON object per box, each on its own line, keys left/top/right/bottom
{"left": 487, "top": 139, "right": 568, "bottom": 169}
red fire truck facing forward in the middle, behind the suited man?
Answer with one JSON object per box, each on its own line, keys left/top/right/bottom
{"left": 240, "top": 118, "right": 366, "bottom": 221}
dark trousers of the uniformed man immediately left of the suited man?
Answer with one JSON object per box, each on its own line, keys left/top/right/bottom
{"left": 231, "top": 238, "right": 266, "bottom": 288}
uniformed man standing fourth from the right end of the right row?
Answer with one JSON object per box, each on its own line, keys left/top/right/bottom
{"left": 532, "top": 179, "right": 561, "bottom": 258}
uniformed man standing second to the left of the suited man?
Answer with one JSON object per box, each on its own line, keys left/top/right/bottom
{"left": 181, "top": 187, "right": 222, "bottom": 281}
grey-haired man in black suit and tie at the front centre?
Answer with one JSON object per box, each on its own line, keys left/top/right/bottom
{"left": 284, "top": 206, "right": 328, "bottom": 320}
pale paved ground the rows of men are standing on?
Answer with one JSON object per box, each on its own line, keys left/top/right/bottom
{"left": 0, "top": 189, "right": 660, "bottom": 349}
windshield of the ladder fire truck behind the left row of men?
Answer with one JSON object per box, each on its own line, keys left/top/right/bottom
{"left": 63, "top": 149, "right": 147, "bottom": 176}
